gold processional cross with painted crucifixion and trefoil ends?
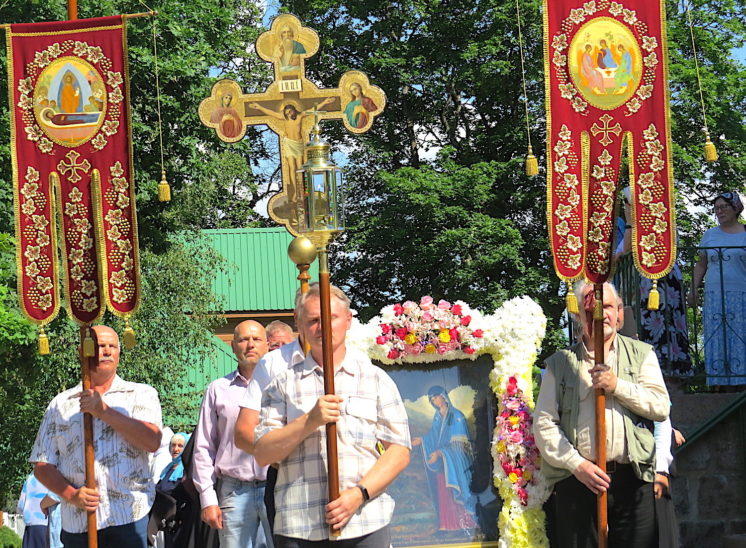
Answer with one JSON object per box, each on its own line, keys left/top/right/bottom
{"left": 199, "top": 14, "right": 386, "bottom": 236}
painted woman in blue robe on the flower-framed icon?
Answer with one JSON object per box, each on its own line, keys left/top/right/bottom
{"left": 412, "top": 386, "right": 476, "bottom": 531}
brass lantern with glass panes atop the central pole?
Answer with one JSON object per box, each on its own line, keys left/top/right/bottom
{"left": 296, "top": 115, "right": 345, "bottom": 248}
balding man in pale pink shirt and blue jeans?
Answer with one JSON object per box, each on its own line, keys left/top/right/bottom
{"left": 193, "top": 320, "right": 272, "bottom": 548}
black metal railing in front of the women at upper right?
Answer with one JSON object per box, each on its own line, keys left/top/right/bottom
{"left": 614, "top": 246, "right": 746, "bottom": 388}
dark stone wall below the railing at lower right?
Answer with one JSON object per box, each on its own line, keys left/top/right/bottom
{"left": 669, "top": 386, "right": 746, "bottom": 548}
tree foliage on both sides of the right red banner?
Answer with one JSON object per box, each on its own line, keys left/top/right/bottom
{"left": 286, "top": 0, "right": 746, "bottom": 353}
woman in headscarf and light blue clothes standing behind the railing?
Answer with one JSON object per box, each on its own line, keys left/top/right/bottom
{"left": 689, "top": 192, "right": 746, "bottom": 387}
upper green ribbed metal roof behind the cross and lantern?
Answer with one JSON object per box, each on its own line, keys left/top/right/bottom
{"left": 202, "top": 228, "right": 318, "bottom": 312}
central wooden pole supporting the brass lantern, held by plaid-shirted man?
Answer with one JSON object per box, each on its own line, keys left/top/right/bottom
{"left": 319, "top": 246, "right": 340, "bottom": 536}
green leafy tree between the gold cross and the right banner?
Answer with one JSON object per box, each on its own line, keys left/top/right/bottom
{"left": 287, "top": 0, "right": 563, "bottom": 347}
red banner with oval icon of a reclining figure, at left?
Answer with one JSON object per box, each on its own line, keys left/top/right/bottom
{"left": 6, "top": 16, "right": 140, "bottom": 325}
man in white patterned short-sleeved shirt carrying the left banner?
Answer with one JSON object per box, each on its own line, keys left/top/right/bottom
{"left": 29, "top": 325, "right": 161, "bottom": 548}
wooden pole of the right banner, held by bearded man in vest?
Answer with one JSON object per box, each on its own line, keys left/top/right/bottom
{"left": 593, "top": 283, "right": 609, "bottom": 548}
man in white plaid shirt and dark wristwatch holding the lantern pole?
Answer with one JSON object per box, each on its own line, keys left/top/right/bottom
{"left": 253, "top": 285, "right": 411, "bottom": 548}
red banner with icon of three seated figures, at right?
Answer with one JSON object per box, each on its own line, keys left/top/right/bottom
{"left": 544, "top": 0, "right": 676, "bottom": 283}
